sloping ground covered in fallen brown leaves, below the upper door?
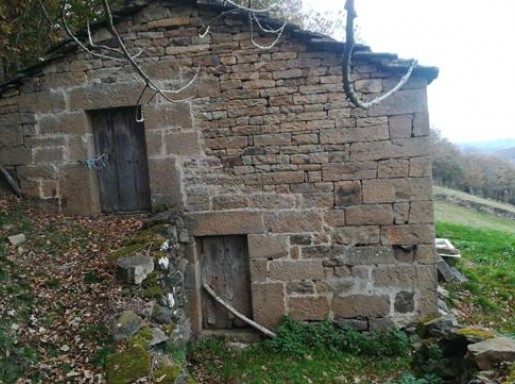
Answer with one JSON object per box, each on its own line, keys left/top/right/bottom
{"left": 0, "top": 196, "right": 141, "bottom": 384}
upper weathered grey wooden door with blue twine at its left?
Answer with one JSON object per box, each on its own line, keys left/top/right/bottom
{"left": 91, "top": 108, "right": 151, "bottom": 213}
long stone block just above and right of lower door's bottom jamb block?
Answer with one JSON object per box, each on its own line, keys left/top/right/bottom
{"left": 268, "top": 259, "right": 324, "bottom": 281}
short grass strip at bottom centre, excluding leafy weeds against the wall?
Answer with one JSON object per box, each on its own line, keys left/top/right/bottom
{"left": 189, "top": 340, "right": 410, "bottom": 384}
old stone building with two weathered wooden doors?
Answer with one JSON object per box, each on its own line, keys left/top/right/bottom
{"left": 0, "top": 0, "right": 437, "bottom": 329}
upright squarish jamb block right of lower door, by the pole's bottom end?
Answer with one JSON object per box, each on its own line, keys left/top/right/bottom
{"left": 252, "top": 283, "right": 286, "bottom": 328}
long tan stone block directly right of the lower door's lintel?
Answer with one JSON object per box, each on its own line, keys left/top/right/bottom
{"left": 264, "top": 211, "right": 323, "bottom": 233}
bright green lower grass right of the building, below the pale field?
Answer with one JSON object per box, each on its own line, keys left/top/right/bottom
{"left": 436, "top": 222, "right": 515, "bottom": 335}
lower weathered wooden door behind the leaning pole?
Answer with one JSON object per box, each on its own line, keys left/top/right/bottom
{"left": 200, "top": 236, "right": 252, "bottom": 329}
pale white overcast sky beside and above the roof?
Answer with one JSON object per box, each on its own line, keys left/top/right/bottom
{"left": 304, "top": 0, "right": 515, "bottom": 143}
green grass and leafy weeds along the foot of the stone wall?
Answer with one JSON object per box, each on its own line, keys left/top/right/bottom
{"left": 189, "top": 317, "right": 411, "bottom": 383}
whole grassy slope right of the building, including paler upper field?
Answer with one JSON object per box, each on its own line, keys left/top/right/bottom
{"left": 435, "top": 191, "right": 515, "bottom": 334}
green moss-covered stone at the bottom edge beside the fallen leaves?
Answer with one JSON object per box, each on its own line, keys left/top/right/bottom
{"left": 106, "top": 345, "right": 152, "bottom": 384}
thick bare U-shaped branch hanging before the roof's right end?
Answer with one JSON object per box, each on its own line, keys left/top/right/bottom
{"left": 342, "top": 0, "right": 417, "bottom": 109}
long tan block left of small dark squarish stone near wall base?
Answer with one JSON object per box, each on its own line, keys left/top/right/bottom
{"left": 332, "top": 295, "right": 390, "bottom": 318}
